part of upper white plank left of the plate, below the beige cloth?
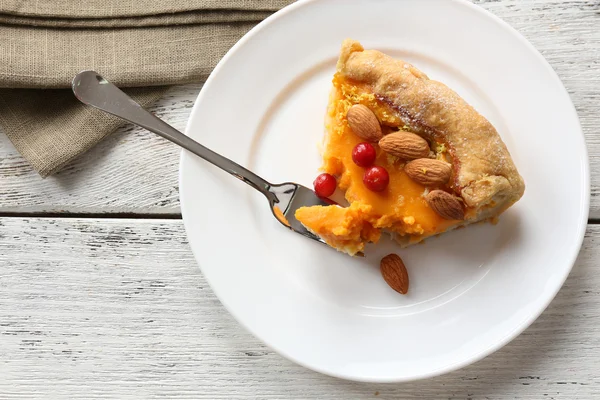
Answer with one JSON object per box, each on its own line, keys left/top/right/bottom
{"left": 0, "top": 84, "right": 197, "bottom": 214}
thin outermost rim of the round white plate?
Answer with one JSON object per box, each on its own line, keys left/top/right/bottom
{"left": 178, "top": 0, "right": 591, "bottom": 383}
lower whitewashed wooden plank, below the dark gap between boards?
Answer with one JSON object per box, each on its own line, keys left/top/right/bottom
{"left": 0, "top": 218, "right": 600, "bottom": 400}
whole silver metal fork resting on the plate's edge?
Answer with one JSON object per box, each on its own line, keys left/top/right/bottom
{"left": 72, "top": 71, "right": 331, "bottom": 243}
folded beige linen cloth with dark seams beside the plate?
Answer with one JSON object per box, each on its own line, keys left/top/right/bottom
{"left": 0, "top": 0, "right": 292, "bottom": 177}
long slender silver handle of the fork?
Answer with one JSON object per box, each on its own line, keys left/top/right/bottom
{"left": 72, "top": 71, "right": 274, "bottom": 200}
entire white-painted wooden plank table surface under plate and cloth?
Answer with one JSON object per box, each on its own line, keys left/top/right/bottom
{"left": 0, "top": 0, "right": 600, "bottom": 400}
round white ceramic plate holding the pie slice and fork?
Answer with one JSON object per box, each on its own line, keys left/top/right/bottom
{"left": 180, "top": 0, "right": 589, "bottom": 382}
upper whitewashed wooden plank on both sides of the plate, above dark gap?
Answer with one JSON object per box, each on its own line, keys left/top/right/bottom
{"left": 0, "top": 0, "right": 600, "bottom": 218}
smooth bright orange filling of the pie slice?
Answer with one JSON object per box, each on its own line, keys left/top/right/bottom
{"left": 296, "top": 75, "right": 457, "bottom": 254}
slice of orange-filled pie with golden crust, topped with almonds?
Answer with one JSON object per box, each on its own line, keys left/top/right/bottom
{"left": 296, "top": 40, "right": 525, "bottom": 255}
